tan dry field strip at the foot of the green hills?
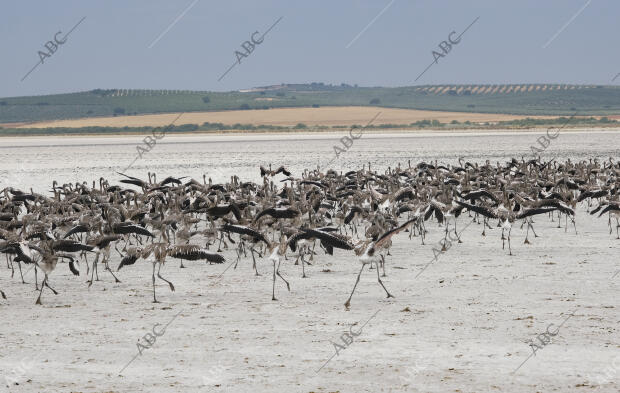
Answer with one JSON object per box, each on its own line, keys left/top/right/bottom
{"left": 16, "top": 106, "right": 552, "bottom": 128}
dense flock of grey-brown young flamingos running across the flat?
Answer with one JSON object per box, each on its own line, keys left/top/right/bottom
{"left": 0, "top": 158, "right": 620, "bottom": 308}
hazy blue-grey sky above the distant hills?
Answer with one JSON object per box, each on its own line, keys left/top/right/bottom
{"left": 0, "top": 0, "right": 620, "bottom": 97}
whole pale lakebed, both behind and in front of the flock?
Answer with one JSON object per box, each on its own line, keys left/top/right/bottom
{"left": 0, "top": 130, "right": 620, "bottom": 393}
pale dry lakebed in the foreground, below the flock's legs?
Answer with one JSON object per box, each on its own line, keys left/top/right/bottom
{"left": 0, "top": 206, "right": 620, "bottom": 393}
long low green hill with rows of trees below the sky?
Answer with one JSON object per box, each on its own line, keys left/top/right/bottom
{"left": 0, "top": 83, "right": 620, "bottom": 123}
